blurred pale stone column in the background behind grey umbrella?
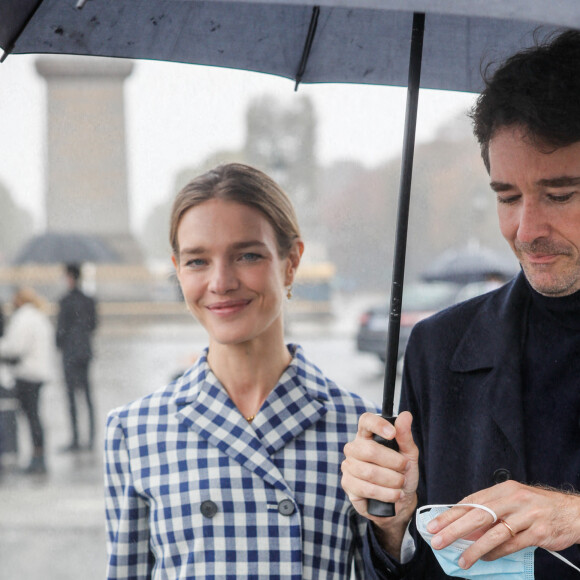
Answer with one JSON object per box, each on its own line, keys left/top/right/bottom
{"left": 36, "top": 56, "right": 141, "bottom": 263}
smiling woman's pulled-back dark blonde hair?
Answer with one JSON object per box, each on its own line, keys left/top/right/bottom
{"left": 169, "top": 163, "right": 300, "bottom": 261}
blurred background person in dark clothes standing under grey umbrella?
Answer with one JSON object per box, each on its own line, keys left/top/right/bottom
{"left": 56, "top": 264, "right": 97, "bottom": 451}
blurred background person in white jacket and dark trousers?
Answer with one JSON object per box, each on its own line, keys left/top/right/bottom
{"left": 0, "top": 288, "right": 54, "bottom": 474}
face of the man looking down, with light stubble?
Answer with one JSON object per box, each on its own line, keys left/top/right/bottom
{"left": 489, "top": 127, "right": 580, "bottom": 296}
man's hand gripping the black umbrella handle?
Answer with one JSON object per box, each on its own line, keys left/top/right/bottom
{"left": 342, "top": 412, "right": 419, "bottom": 558}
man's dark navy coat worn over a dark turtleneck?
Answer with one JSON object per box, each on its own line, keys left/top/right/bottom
{"left": 365, "top": 273, "right": 580, "bottom": 580}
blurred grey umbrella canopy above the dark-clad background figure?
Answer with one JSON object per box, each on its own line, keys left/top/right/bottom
{"left": 14, "top": 233, "right": 120, "bottom": 265}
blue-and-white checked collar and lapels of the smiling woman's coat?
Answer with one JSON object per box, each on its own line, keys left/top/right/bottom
{"left": 174, "top": 345, "right": 328, "bottom": 492}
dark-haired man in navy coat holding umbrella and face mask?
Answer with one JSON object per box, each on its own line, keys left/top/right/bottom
{"left": 343, "top": 31, "right": 580, "bottom": 580}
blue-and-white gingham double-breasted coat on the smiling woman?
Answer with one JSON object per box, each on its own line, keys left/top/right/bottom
{"left": 105, "top": 345, "right": 377, "bottom": 580}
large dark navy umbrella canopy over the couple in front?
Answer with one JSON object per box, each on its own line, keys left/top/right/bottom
{"left": 0, "top": 0, "right": 580, "bottom": 92}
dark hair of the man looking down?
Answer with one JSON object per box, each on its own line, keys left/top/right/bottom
{"left": 470, "top": 30, "right": 580, "bottom": 171}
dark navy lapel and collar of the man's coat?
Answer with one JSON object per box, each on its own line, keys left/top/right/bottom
{"left": 451, "top": 274, "right": 528, "bottom": 477}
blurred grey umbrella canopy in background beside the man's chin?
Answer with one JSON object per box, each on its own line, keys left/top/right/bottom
{"left": 421, "top": 245, "right": 518, "bottom": 284}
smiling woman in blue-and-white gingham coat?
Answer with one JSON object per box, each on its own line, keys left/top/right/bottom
{"left": 106, "top": 164, "right": 376, "bottom": 579}
